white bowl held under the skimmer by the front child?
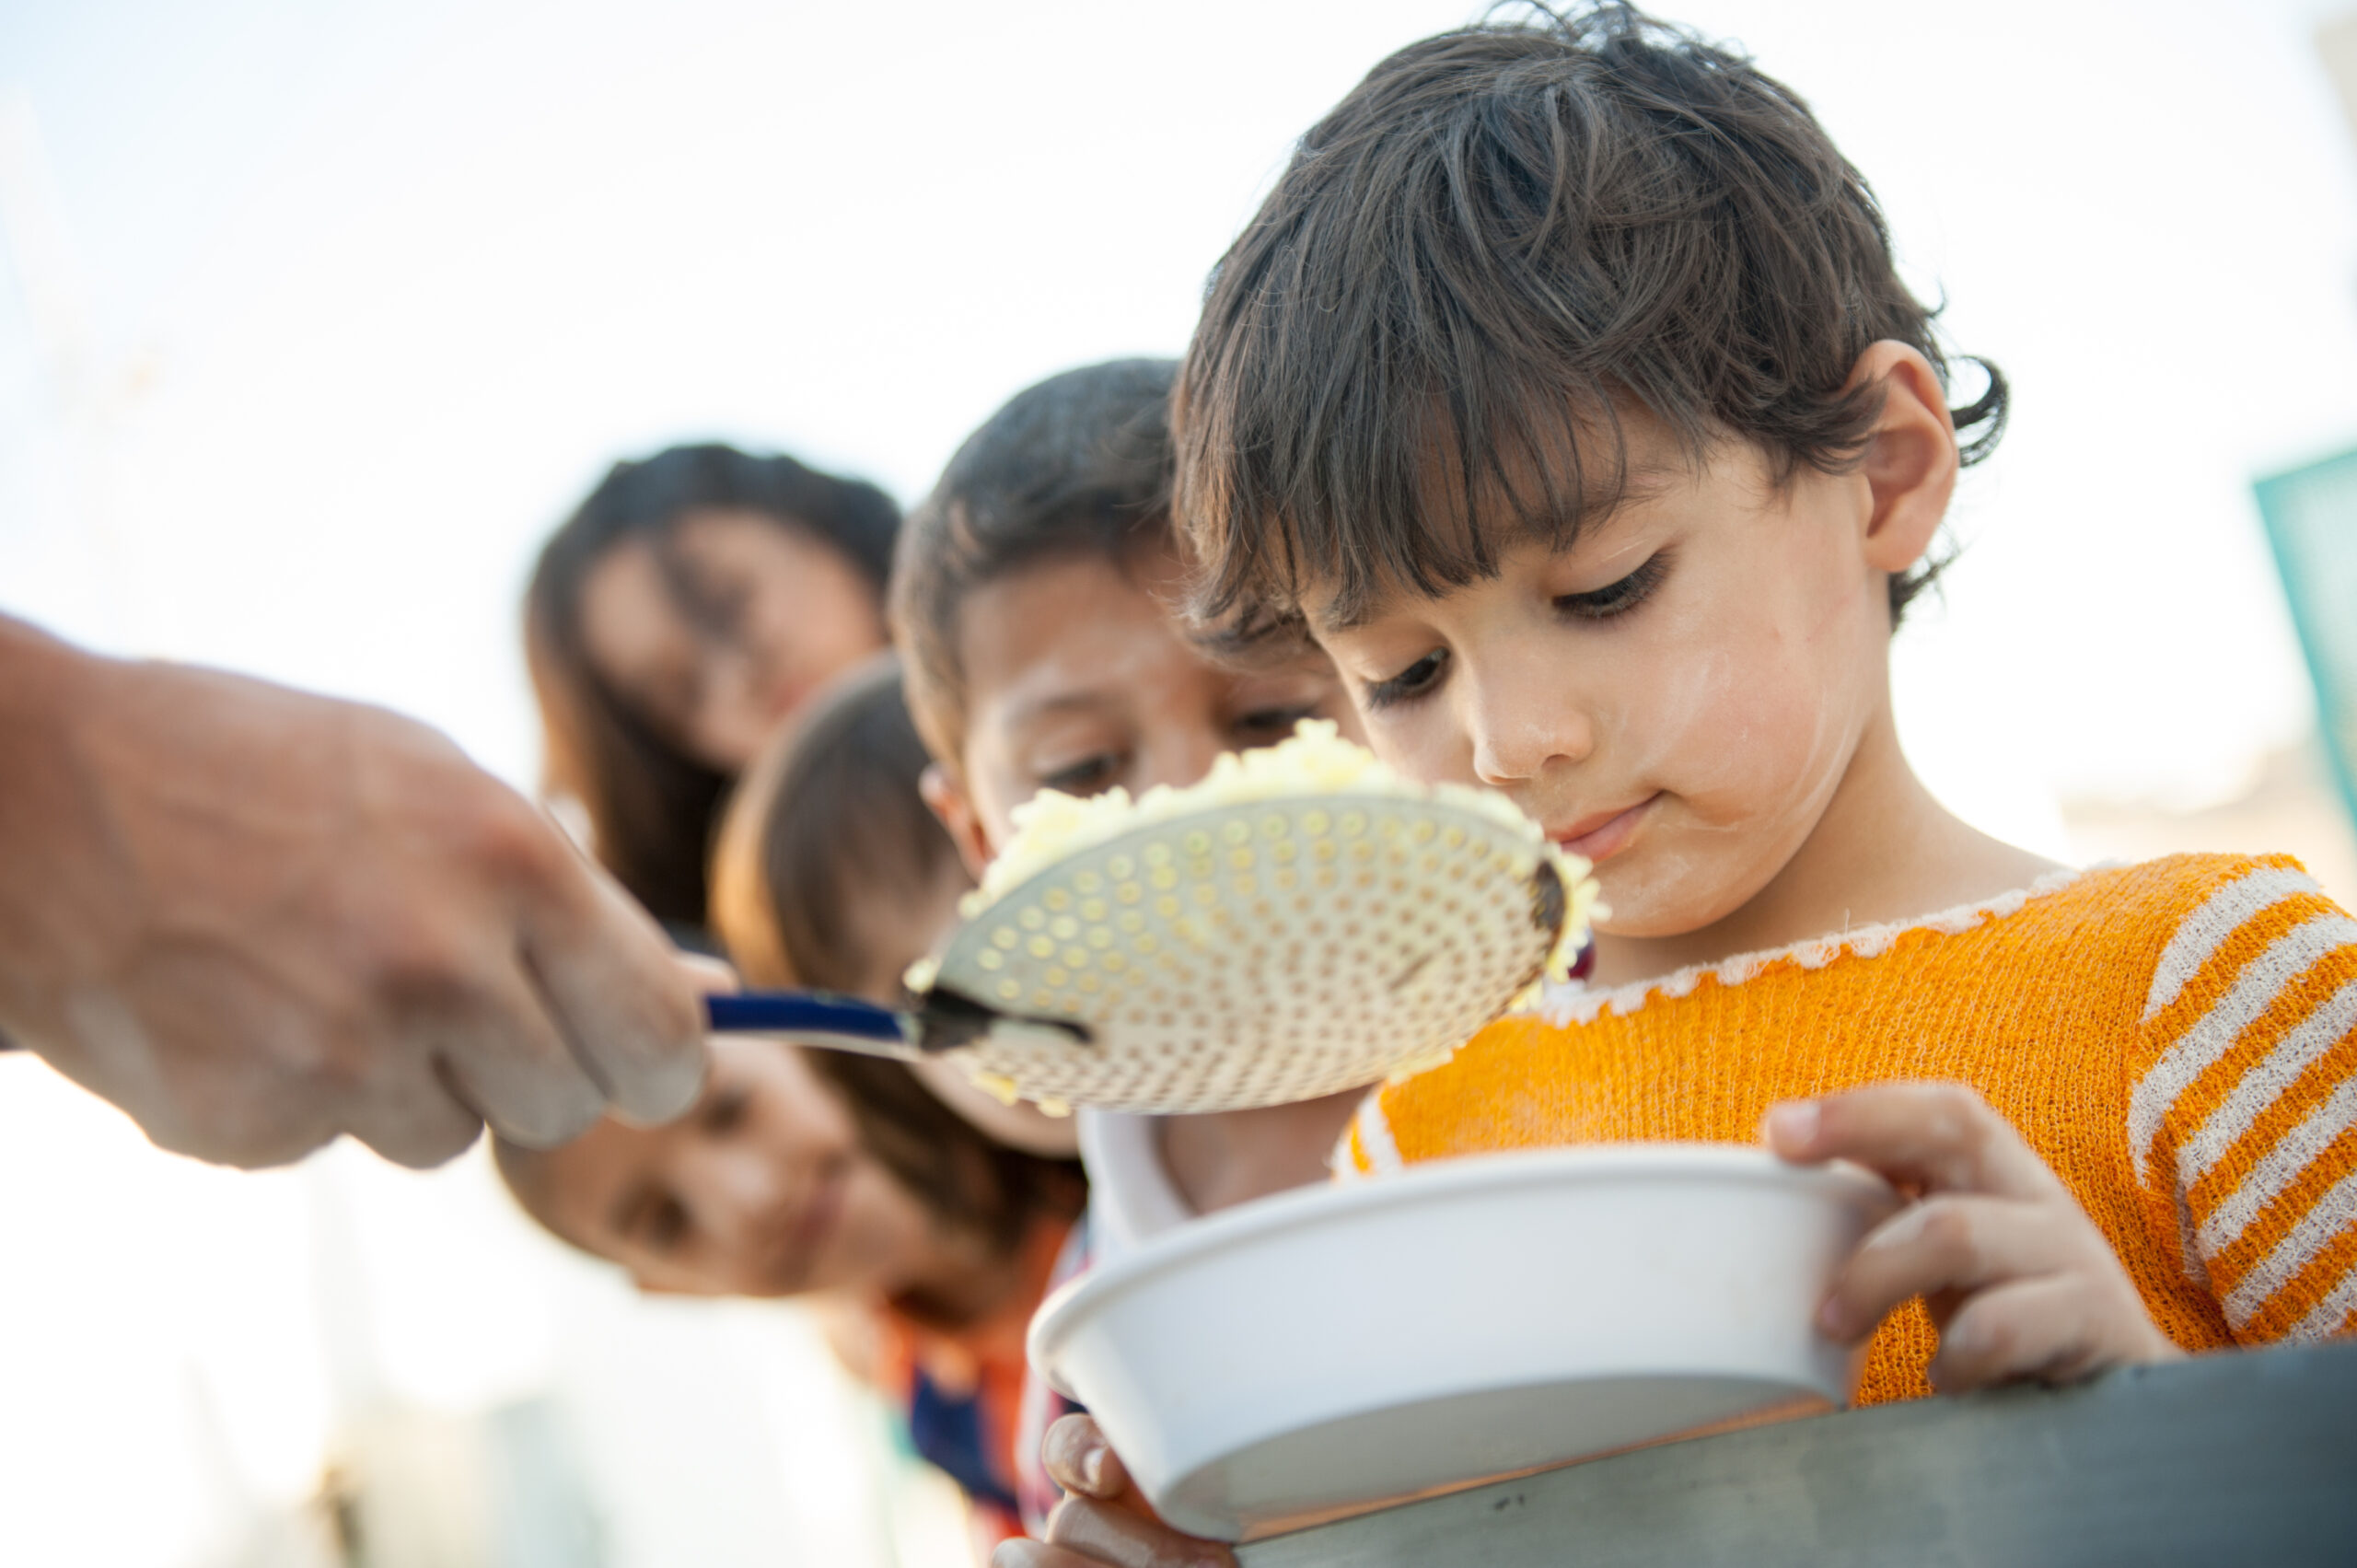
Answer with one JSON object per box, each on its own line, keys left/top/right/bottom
{"left": 1030, "top": 1144, "right": 1898, "bottom": 1539}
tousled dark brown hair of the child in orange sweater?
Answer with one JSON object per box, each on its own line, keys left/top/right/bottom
{"left": 1174, "top": 5, "right": 2006, "bottom": 642}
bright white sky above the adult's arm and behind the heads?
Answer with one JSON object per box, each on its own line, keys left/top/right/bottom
{"left": 0, "top": 0, "right": 2357, "bottom": 832}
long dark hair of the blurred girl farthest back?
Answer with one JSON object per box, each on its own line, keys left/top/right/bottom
{"left": 523, "top": 446, "right": 900, "bottom": 926}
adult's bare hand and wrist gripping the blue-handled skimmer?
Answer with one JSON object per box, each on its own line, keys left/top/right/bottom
{"left": 0, "top": 618, "right": 702, "bottom": 1167}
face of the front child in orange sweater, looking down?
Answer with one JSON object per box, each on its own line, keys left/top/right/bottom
{"left": 1306, "top": 422, "right": 1890, "bottom": 936}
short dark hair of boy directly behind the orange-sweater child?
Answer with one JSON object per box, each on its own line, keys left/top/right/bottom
{"left": 891, "top": 358, "right": 1178, "bottom": 766}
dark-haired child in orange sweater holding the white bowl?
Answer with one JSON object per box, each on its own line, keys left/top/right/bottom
{"left": 997, "top": 7, "right": 2357, "bottom": 1568}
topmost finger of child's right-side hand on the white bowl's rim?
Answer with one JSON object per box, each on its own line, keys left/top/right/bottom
{"left": 1760, "top": 1082, "right": 2058, "bottom": 1198}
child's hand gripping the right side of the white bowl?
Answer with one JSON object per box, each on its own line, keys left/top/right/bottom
{"left": 1760, "top": 1082, "right": 2183, "bottom": 1393}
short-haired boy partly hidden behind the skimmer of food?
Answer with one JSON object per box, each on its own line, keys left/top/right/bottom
{"left": 891, "top": 358, "right": 1355, "bottom": 1235}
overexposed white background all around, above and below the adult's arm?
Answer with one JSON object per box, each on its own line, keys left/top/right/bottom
{"left": 0, "top": 0, "right": 2357, "bottom": 1568}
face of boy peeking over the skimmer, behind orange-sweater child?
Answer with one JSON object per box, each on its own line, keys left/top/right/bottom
{"left": 934, "top": 552, "right": 1355, "bottom": 865}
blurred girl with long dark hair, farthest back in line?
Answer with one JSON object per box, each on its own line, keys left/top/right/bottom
{"left": 523, "top": 446, "right": 900, "bottom": 929}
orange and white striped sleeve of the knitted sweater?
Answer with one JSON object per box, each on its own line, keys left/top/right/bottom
{"left": 2129, "top": 858, "right": 2357, "bottom": 1344}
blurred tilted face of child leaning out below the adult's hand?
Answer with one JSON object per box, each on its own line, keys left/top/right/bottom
{"left": 530, "top": 1035, "right": 938, "bottom": 1296}
